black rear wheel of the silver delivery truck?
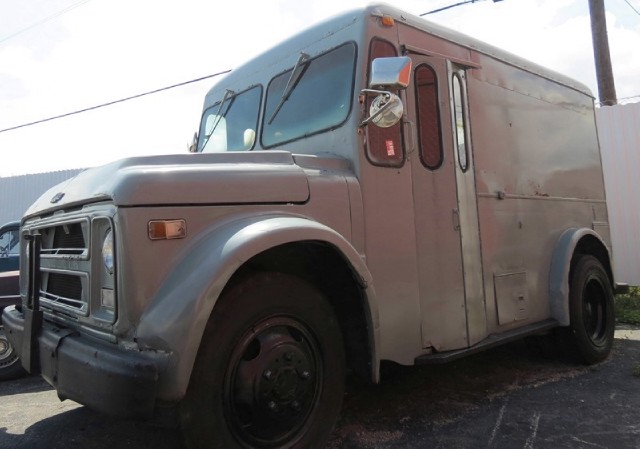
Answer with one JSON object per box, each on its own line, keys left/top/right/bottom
{"left": 569, "top": 256, "right": 615, "bottom": 364}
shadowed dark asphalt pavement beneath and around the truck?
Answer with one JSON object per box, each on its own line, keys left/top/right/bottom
{"left": 0, "top": 329, "right": 640, "bottom": 449}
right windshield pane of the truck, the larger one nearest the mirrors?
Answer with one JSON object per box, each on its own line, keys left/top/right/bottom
{"left": 262, "top": 43, "right": 356, "bottom": 148}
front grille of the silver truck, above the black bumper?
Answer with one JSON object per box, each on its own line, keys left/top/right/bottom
{"left": 20, "top": 205, "right": 117, "bottom": 326}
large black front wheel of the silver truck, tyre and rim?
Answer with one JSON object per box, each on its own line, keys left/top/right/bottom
{"left": 180, "top": 273, "right": 345, "bottom": 449}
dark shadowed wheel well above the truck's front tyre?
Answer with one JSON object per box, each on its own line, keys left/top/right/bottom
{"left": 228, "top": 241, "right": 373, "bottom": 381}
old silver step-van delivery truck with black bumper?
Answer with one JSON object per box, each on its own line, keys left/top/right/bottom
{"left": 3, "top": 5, "right": 615, "bottom": 448}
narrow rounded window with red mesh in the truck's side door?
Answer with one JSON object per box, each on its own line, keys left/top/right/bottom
{"left": 415, "top": 64, "right": 444, "bottom": 170}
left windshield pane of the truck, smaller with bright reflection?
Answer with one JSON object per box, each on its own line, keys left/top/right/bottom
{"left": 198, "top": 86, "right": 262, "bottom": 153}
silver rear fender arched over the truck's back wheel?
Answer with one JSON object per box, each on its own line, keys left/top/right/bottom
{"left": 549, "top": 228, "right": 608, "bottom": 326}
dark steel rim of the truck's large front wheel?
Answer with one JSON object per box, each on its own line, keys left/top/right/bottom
{"left": 223, "top": 316, "right": 324, "bottom": 447}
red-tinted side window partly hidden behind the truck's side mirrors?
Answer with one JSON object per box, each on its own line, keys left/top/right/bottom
{"left": 365, "top": 39, "right": 404, "bottom": 167}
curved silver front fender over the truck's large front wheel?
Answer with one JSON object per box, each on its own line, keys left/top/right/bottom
{"left": 136, "top": 216, "right": 378, "bottom": 401}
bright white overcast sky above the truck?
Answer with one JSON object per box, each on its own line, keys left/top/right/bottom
{"left": 0, "top": 0, "right": 640, "bottom": 177}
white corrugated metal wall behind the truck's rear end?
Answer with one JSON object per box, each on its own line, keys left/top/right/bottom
{"left": 596, "top": 103, "right": 640, "bottom": 286}
